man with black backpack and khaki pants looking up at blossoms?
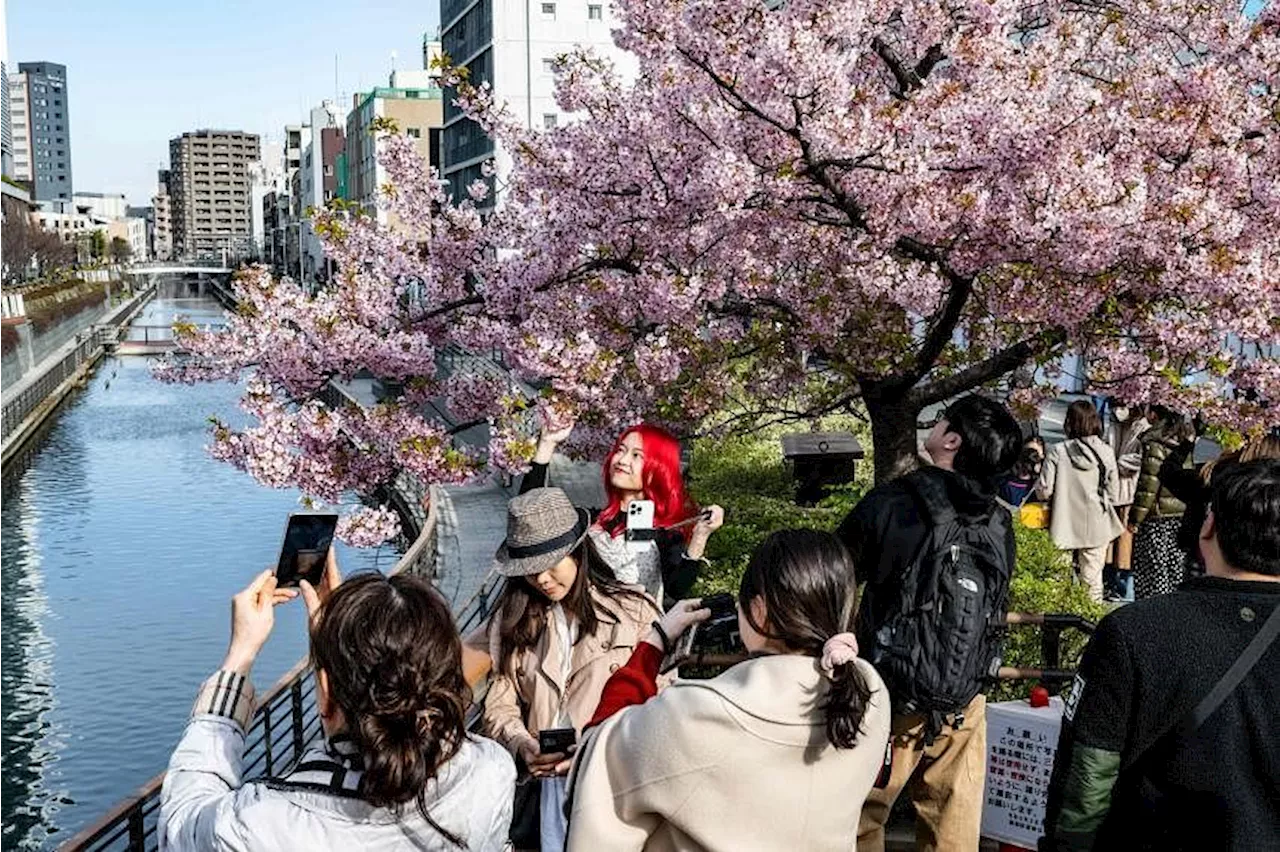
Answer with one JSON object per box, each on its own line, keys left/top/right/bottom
{"left": 838, "top": 395, "right": 1023, "bottom": 852}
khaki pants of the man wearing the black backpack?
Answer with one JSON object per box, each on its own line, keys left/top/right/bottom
{"left": 858, "top": 695, "right": 987, "bottom": 852}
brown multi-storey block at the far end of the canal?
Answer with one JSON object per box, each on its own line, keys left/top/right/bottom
{"left": 169, "top": 129, "right": 261, "bottom": 262}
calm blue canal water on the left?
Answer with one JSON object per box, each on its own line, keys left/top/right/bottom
{"left": 0, "top": 284, "right": 397, "bottom": 849}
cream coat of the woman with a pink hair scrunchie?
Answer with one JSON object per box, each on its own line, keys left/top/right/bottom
{"left": 567, "top": 655, "right": 890, "bottom": 852}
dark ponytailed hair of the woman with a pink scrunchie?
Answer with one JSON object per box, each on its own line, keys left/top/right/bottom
{"left": 737, "top": 530, "right": 872, "bottom": 748}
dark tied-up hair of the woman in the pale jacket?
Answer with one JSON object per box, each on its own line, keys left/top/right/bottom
{"left": 311, "top": 573, "right": 470, "bottom": 847}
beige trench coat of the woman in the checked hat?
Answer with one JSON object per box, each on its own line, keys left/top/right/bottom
{"left": 484, "top": 586, "right": 662, "bottom": 755}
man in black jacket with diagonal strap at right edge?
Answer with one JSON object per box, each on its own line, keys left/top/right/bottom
{"left": 1041, "top": 459, "right": 1280, "bottom": 852}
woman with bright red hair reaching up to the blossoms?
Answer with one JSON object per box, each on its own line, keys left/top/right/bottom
{"left": 520, "top": 422, "right": 724, "bottom": 603}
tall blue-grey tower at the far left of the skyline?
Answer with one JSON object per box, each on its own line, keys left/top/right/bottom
{"left": 9, "top": 61, "right": 73, "bottom": 200}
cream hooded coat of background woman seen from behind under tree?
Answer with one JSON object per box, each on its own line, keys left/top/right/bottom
{"left": 1036, "top": 436, "right": 1123, "bottom": 550}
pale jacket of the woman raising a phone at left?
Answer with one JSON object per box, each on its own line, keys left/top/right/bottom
{"left": 159, "top": 675, "right": 516, "bottom": 852}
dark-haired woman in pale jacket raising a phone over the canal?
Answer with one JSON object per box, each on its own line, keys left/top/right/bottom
{"left": 157, "top": 551, "right": 516, "bottom": 852}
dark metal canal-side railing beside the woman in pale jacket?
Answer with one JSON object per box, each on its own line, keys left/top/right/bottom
{"left": 59, "top": 500, "right": 460, "bottom": 852}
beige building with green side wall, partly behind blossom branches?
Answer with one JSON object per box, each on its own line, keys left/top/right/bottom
{"left": 344, "top": 72, "right": 444, "bottom": 223}
